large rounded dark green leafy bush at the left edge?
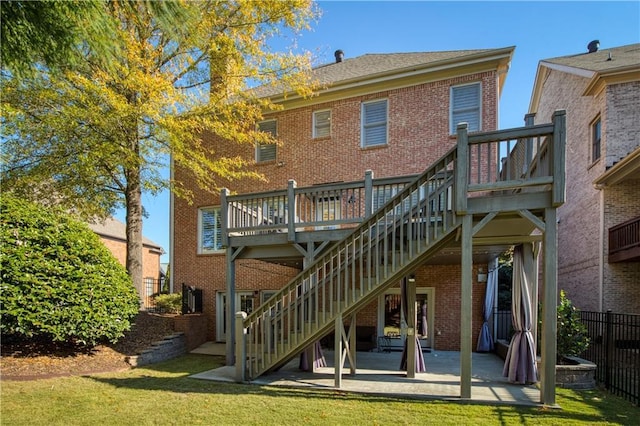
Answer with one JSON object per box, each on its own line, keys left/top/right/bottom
{"left": 0, "top": 194, "right": 139, "bottom": 346}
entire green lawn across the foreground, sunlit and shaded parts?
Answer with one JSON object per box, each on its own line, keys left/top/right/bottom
{"left": 0, "top": 355, "right": 640, "bottom": 426}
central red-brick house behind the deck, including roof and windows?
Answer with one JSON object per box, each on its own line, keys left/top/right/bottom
{"left": 171, "top": 47, "right": 516, "bottom": 350}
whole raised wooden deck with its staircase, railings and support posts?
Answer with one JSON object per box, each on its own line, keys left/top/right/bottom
{"left": 221, "top": 111, "right": 566, "bottom": 404}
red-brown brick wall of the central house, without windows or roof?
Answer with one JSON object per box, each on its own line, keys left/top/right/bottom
{"left": 172, "top": 71, "right": 498, "bottom": 344}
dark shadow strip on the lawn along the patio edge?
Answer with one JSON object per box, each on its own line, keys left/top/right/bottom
{"left": 82, "top": 354, "right": 638, "bottom": 424}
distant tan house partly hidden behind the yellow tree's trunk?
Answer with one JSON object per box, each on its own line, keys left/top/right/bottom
{"left": 89, "top": 217, "right": 164, "bottom": 306}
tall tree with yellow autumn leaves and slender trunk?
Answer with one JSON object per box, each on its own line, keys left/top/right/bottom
{"left": 2, "top": 0, "right": 315, "bottom": 289}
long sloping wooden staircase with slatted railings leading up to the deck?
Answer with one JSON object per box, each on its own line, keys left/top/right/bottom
{"left": 240, "top": 149, "right": 459, "bottom": 379}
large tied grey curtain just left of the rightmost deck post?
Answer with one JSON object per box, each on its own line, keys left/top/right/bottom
{"left": 502, "top": 245, "right": 538, "bottom": 384}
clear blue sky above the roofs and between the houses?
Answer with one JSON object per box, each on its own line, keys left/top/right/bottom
{"left": 121, "top": 1, "right": 640, "bottom": 262}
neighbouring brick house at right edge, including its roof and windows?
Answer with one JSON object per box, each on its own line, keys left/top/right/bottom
{"left": 529, "top": 42, "right": 640, "bottom": 314}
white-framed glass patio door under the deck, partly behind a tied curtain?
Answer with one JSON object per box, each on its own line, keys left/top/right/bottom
{"left": 378, "top": 287, "right": 435, "bottom": 350}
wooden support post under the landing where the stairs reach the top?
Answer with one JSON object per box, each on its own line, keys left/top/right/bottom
{"left": 460, "top": 214, "right": 473, "bottom": 399}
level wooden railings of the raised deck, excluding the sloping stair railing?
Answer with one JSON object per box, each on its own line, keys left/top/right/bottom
{"left": 221, "top": 112, "right": 564, "bottom": 241}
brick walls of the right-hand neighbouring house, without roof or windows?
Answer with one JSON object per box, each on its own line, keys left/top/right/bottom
{"left": 535, "top": 70, "right": 640, "bottom": 313}
